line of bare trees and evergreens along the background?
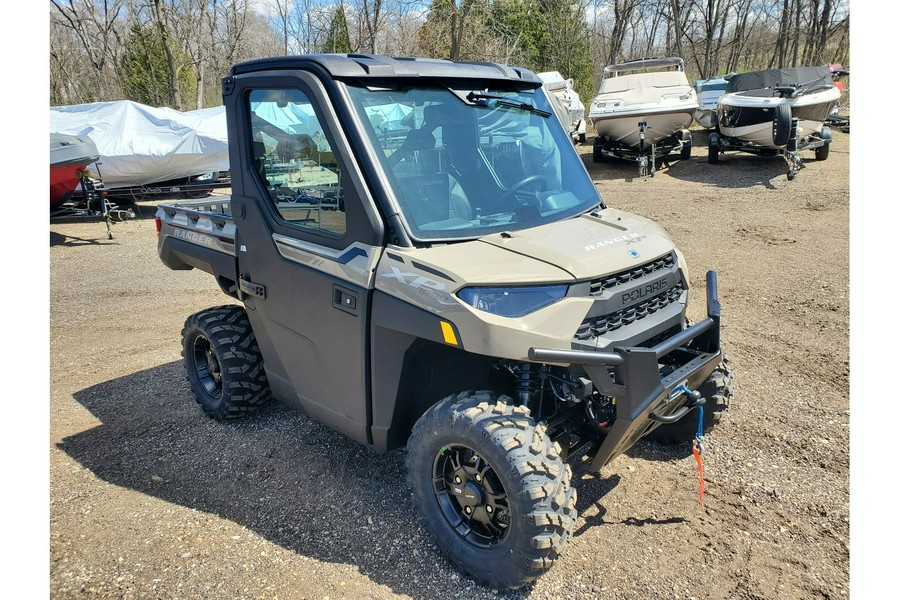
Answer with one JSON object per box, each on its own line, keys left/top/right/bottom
{"left": 50, "top": 0, "right": 850, "bottom": 110}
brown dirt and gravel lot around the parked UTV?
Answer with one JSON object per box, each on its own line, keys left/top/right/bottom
{"left": 49, "top": 132, "right": 850, "bottom": 600}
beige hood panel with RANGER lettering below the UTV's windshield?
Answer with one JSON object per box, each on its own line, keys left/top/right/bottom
{"left": 406, "top": 208, "right": 674, "bottom": 285}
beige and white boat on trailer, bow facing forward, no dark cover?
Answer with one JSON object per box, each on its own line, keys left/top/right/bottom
{"left": 588, "top": 57, "right": 699, "bottom": 175}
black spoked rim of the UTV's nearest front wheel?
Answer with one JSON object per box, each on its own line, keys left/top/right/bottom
{"left": 431, "top": 444, "right": 511, "bottom": 548}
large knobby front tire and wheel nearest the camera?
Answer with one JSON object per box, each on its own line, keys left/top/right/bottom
{"left": 406, "top": 392, "right": 577, "bottom": 588}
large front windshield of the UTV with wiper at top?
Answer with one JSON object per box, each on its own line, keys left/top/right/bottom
{"left": 348, "top": 86, "right": 600, "bottom": 240}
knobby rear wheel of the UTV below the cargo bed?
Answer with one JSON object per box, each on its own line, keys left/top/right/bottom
{"left": 181, "top": 305, "right": 272, "bottom": 421}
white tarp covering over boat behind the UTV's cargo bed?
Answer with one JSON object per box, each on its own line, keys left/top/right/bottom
{"left": 50, "top": 100, "right": 229, "bottom": 188}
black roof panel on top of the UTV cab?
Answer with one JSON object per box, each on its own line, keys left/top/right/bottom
{"left": 231, "top": 54, "right": 541, "bottom": 85}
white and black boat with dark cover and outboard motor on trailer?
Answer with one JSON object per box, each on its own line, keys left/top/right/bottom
{"left": 709, "top": 65, "right": 841, "bottom": 179}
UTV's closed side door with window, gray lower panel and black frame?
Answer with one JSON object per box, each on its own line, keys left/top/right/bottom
{"left": 226, "top": 71, "right": 383, "bottom": 443}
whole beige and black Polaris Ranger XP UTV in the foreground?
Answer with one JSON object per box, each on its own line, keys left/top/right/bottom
{"left": 156, "top": 55, "right": 728, "bottom": 587}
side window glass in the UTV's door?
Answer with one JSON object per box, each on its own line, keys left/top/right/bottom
{"left": 249, "top": 89, "right": 347, "bottom": 235}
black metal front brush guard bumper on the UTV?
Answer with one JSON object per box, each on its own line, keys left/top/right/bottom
{"left": 528, "top": 271, "right": 722, "bottom": 471}
